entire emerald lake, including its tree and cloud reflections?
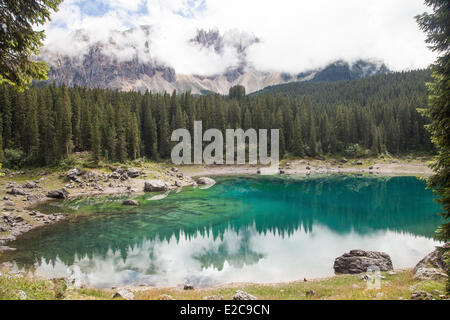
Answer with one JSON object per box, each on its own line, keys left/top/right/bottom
{"left": 1, "top": 175, "right": 441, "bottom": 287}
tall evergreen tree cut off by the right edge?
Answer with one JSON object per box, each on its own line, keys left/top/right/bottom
{"left": 416, "top": 0, "right": 450, "bottom": 292}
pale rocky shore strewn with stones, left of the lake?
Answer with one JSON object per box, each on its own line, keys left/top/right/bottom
{"left": 0, "top": 167, "right": 215, "bottom": 249}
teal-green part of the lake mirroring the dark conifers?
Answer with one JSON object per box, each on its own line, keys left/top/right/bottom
{"left": 1, "top": 175, "right": 440, "bottom": 269}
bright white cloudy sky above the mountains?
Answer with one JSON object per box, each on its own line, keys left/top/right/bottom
{"left": 45, "top": 0, "right": 435, "bottom": 74}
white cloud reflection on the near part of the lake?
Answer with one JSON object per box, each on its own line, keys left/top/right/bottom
{"left": 31, "top": 225, "right": 437, "bottom": 287}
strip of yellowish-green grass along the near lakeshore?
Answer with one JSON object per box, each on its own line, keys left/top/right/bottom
{"left": 0, "top": 270, "right": 445, "bottom": 300}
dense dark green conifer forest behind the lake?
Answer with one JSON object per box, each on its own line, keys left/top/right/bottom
{"left": 0, "top": 71, "right": 433, "bottom": 166}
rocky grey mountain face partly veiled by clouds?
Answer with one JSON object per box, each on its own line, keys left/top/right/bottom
{"left": 38, "top": 26, "right": 388, "bottom": 94}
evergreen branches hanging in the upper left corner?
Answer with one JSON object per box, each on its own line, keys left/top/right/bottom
{"left": 0, "top": 0, "right": 62, "bottom": 90}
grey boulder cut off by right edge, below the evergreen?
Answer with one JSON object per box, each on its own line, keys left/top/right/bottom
{"left": 413, "top": 244, "right": 449, "bottom": 280}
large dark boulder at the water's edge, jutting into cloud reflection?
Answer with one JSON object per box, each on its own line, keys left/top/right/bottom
{"left": 333, "top": 250, "right": 393, "bottom": 274}
